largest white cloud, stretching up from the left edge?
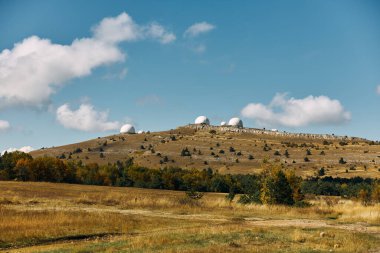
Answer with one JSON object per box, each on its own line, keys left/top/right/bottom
{"left": 0, "top": 13, "right": 175, "bottom": 108}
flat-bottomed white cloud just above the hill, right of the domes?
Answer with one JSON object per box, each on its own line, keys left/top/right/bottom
{"left": 241, "top": 94, "right": 351, "bottom": 127}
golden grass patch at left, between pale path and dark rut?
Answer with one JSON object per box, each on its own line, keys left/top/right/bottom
{"left": 0, "top": 206, "right": 191, "bottom": 248}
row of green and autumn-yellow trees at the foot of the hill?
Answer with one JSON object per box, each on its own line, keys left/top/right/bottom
{"left": 0, "top": 151, "right": 380, "bottom": 205}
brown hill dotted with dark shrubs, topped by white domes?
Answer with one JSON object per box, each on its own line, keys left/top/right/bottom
{"left": 31, "top": 125, "right": 380, "bottom": 178}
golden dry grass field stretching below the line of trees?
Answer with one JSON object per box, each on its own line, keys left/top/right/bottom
{"left": 0, "top": 181, "right": 380, "bottom": 252}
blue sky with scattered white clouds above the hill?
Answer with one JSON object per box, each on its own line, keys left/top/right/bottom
{"left": 0, "top": 0, "right": 380, "bottom": 151}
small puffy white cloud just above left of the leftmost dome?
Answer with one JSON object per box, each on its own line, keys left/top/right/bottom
{"left": 56, "top": 103, "right": 120, "bottom": 132}
